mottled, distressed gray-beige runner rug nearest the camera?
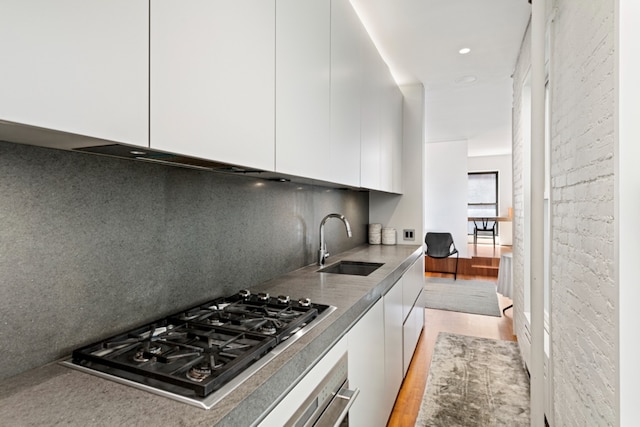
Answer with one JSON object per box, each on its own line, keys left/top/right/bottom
{"left": 415, "top": 332, "right": 530, "bottom": 427}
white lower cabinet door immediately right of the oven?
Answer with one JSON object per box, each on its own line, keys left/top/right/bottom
{"left": 348, "top": 299, "right": 388, "bottom": 427}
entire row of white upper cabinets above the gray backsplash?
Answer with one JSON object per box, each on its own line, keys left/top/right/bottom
{"left": 0, "top": 0, "right": 402, "bottom": 189}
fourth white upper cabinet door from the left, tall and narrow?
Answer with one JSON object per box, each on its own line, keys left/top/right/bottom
{"left": 329, "top": 0, "right": 366, "bottom": 186}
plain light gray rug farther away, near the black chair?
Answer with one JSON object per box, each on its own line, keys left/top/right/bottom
{"left": 424, "top": 277, "right": 502, "bottom": 317}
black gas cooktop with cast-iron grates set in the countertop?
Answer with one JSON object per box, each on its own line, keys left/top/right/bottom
{"left": 62, "top": 290, "right": 335, "bottom": 409}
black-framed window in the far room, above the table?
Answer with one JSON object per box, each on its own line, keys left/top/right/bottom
{"left": 467, "top": 171, "right": 498, "bottom": 234}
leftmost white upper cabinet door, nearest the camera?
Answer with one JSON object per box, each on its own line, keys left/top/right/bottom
{"left": 0, "top": 0, "right": 149, "bottom": 146}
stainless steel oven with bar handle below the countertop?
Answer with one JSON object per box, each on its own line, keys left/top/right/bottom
{"left": 284, "top": 354, "right": 360, "bottom": 427}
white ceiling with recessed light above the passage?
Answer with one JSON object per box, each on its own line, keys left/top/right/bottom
{"left": 351, "top": 0, "right": 531, "bottom": 156}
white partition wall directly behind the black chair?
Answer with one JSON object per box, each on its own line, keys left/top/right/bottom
{"left": 424, "top": 140, "right": 468, "bottom": 258}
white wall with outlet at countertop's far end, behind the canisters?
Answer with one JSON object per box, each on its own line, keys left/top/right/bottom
{"left": 369, "top": 84, "right": 424, "bottom": 245}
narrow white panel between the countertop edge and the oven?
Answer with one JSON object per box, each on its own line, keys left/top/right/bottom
{"left": 258, "top": 337, "right": 347, "bottom": 427}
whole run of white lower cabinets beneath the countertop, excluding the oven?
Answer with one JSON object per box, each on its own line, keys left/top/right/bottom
{"left": 258, "top": 257, "right": 424, "bottom": 427}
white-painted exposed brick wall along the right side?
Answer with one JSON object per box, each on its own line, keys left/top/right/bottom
{"left": 513, "top": 0, "right": 617, "bottom": 426}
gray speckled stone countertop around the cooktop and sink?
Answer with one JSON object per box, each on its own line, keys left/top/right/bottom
{"left": 0, "top": 245, "right": 422, "bottom": 427}
